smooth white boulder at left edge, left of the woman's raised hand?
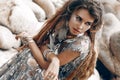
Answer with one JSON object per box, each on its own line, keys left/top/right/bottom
{"left": 0, "top": 26, "right": 21, "bottom": 49}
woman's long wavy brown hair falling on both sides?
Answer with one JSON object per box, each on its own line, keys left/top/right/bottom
{"left": 34, "top": 0, "right": 103, "bottom": 80}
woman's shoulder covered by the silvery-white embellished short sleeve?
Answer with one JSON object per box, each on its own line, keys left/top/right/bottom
{"left": 64, "top": 35, "right": 90, "bottom": 53}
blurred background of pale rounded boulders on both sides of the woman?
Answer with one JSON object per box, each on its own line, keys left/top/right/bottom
{"left": 0, "top": 0, "right": 120, "bottom": 80}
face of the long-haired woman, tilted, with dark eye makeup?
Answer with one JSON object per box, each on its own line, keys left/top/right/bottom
{"left": 68, "top": 9, "right": 94, "bottom": 35}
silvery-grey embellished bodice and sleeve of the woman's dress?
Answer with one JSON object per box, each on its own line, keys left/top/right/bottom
{"left": 48, "top": 34, "right": 90, "bottom": 80}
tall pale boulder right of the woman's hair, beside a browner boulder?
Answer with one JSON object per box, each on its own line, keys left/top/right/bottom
{"left": 96, "top": 13, "right": 120, "bottom": 75}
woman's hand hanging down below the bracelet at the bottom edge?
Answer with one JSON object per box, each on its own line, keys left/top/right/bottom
{"left": 43, "top": 57, "right": 60, "bottom": 80}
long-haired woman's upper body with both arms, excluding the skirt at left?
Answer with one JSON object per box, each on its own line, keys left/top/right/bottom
{"left": 18, "top": 0, "right": 102, "bottom": 80}
